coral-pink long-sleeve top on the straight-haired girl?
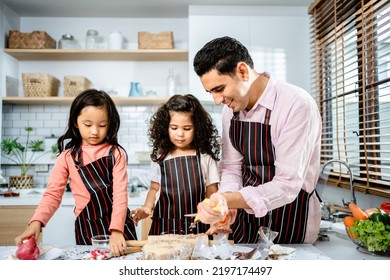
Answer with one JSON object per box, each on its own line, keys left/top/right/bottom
{"left": 30, "top": 143, "right": 128, "bottom": 232}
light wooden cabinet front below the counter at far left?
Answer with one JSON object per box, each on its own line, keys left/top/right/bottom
{"left": 0, "top": 205, "right": 37, "bottom": 246}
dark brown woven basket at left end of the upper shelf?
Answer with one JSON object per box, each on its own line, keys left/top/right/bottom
{"left": 8, "top": 30, "right": 57, "bottom": 49}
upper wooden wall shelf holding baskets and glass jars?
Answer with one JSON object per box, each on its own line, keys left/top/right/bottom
{"left": 4, "top": 49, "right": 188, "bottom": 61}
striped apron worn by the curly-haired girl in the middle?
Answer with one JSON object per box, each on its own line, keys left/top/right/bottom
{"left": 149, "top": 152, "right": 209, "bottom": 235}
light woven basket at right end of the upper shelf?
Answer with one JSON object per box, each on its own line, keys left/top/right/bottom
{"left": 138, "top": 31, "right": 173, "bottom": 49}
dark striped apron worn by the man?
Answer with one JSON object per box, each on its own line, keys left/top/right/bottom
{"left": 229, "top": 110, "right": 312, "bottom": 243}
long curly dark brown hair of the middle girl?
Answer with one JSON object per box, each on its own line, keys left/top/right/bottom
{"left": 148, "top": 94, "right": 221, "bottom": 162}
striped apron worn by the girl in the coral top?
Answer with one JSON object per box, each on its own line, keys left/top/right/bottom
{"left": 72, "top": 147, "right": 137, "bottom": 245}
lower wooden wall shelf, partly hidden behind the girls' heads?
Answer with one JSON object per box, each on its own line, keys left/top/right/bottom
{"left": 3, "top": 96, "right": 168, "bottom": 105}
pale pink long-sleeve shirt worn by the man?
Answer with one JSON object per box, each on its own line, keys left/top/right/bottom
{"left": 218, "top": 78, "right": 322, "bottom": 243}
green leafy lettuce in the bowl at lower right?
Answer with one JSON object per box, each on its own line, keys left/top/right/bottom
{"left": 350, "top": 220, "right": 390, "bottom": 252}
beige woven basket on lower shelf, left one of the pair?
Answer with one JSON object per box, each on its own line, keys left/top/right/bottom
{"left": 22, "top": 73, "right": 59, "bottom": 97}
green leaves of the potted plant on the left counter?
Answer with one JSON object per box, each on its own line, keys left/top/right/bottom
{"left": 1, "top": 127, "right": 45, "bottom": 175}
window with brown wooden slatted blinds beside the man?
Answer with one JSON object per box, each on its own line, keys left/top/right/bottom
{"left": 309, "top": 0, "right": 390, "bottom": 197}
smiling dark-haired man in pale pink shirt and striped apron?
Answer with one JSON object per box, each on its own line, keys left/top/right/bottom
{"left": 194, "top": 37, "right": 322, "bottom": 243}
